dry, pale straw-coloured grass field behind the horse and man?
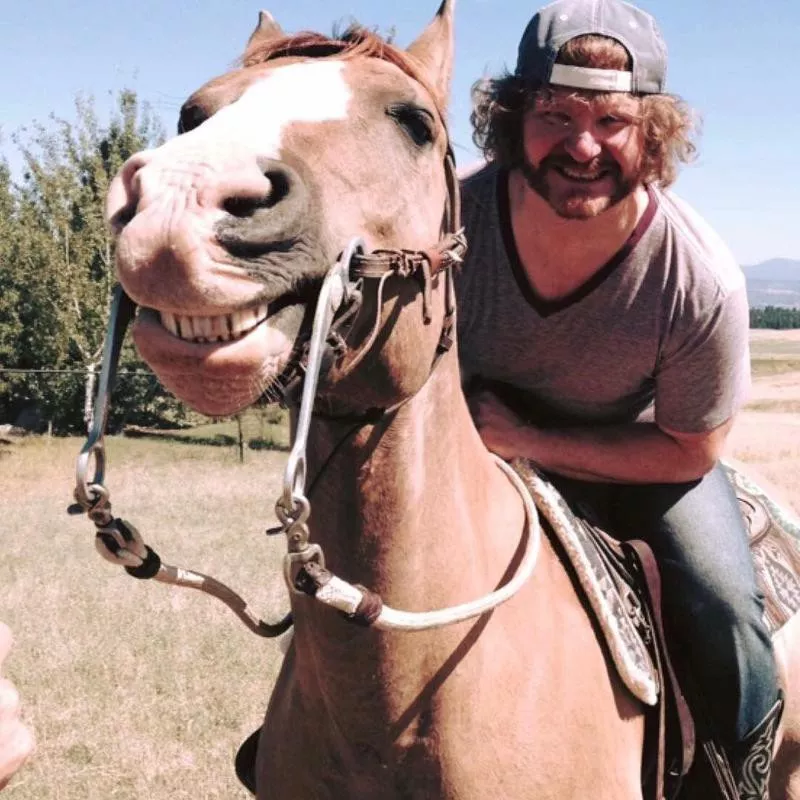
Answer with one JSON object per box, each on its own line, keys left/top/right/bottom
{"left": 0, "top": 332, "right": 800, "bottom": 800}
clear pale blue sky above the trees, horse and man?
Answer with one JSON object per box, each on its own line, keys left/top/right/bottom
{"left": 0, "top": 0, "right": 800, "bottom": 268}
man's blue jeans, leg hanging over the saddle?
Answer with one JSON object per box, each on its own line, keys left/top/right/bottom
{"left": 548, "top": 466, "right": 778, "bottom": 746}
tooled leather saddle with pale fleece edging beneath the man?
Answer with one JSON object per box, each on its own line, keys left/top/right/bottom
{"left": 235, "top": 460, "right": 800, "bottom": 800}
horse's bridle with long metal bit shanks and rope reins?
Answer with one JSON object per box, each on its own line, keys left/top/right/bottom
{"left": 70, "top": 69, "right": 541, "bottom": 637}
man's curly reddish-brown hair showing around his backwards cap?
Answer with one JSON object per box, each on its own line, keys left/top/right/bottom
{"left": 470, "top": 35, "right": 699, "bottom": 187}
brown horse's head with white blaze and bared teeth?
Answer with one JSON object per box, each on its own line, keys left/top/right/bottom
{"left": 108, "top": 0, "right": 454, "bottom": 415}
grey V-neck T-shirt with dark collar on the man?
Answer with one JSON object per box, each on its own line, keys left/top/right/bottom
{"left": 456, "top": 164, "right": 750, "bottom": 433}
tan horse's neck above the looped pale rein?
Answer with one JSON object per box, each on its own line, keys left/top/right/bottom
{"left": 309, "top": 360, "right": 522, "bottom": 592}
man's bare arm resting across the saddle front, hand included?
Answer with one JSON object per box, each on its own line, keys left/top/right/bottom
{"left": 470, "top": 393, "right": 733, "bottom": 483}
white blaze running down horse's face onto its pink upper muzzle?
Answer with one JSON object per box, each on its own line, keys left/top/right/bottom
{"left": 109, "top": 60, "right": 353, "bottom": 324}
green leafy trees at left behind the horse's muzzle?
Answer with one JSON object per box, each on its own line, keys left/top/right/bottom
{"left": 0, "top": 91, "right": 184, "bottom": 432}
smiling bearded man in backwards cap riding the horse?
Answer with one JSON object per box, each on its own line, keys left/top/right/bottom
{"left": 457, "top": 0, "right": 782, "bottom": 800}
